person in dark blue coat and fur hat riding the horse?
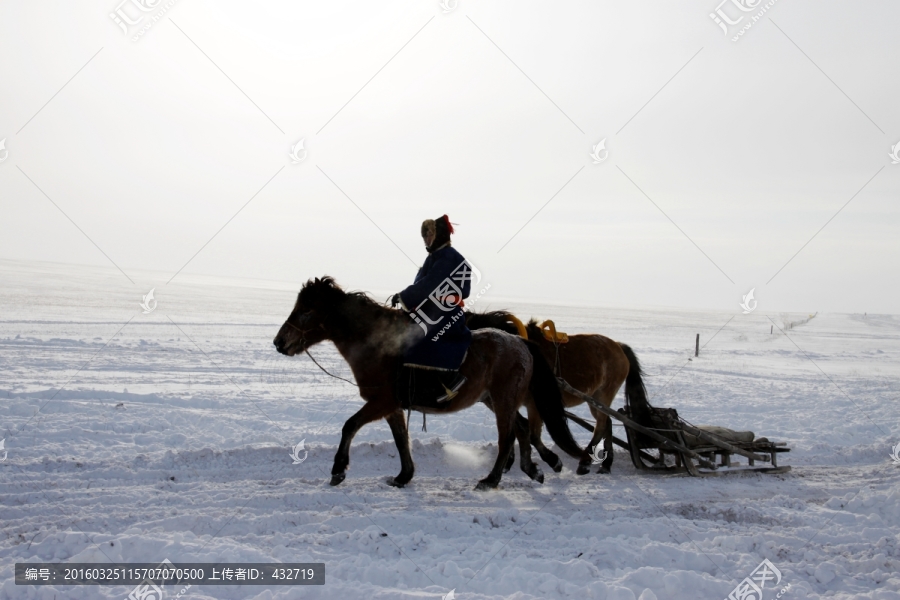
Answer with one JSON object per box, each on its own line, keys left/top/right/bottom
{"left": 391, "top": 215, "right": 472, "bottom": 405}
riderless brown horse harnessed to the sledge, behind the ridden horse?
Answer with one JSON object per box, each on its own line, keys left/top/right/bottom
{"left": 466, "top": 310, "right": 649, "bottom": 475}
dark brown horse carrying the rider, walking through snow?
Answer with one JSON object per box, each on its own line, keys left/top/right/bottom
{"left": 274, "top": 277, "right": 583, "bottom": 490}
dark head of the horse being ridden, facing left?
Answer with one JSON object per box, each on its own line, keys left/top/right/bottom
{"left": 273, "top": 276, "right": 346, "bottom": 356}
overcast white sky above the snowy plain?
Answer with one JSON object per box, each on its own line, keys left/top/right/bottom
{"left": 0, "top": 0, "right": 900, "bottom": 313}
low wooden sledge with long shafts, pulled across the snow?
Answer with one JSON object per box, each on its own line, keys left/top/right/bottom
{"left": 557, "top": 377, "right": 791, "bottom": 477}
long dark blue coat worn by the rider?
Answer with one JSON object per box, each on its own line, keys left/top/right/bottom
{"left": 400, "top": 246, "right": 472, "bottom": 371}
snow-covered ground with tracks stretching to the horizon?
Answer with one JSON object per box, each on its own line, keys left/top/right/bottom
{"left": 0, "top": 261, "right": 900, "bottom": 600}
